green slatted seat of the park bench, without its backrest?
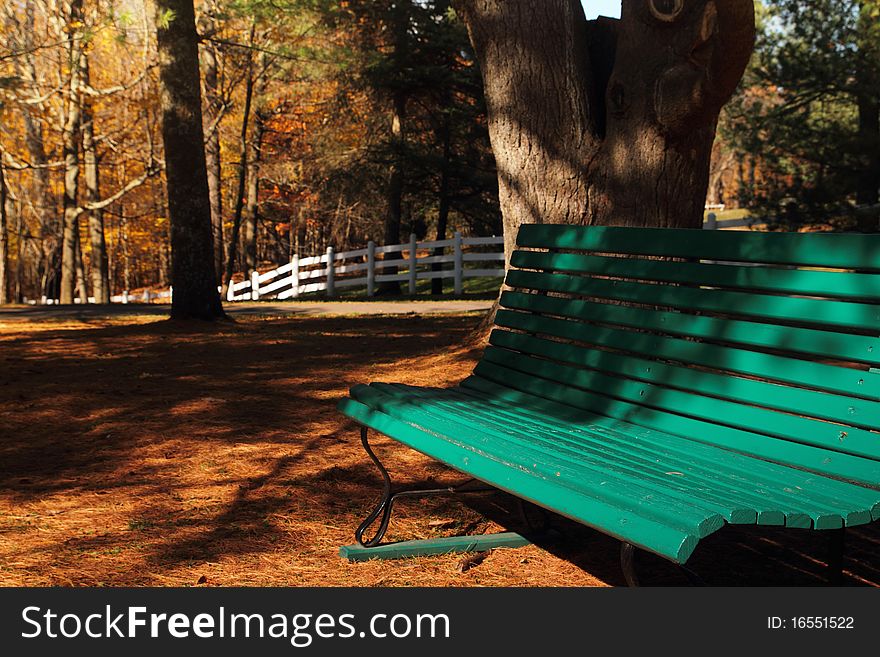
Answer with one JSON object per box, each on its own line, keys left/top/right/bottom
{"left": 340, "top": 377, "right": 880, "bottom": 564}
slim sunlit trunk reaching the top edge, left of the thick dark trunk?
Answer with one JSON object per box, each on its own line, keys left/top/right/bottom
{"left": 60, "top": 0, "right": 83, "bottom": 303}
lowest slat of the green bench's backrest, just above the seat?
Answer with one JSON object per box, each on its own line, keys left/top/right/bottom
{"left": 462, "top": 362, "right": 880, "bottom": 486}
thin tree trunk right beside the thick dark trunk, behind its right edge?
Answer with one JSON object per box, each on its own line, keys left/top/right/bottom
{"left": 201, "top": 0, "right": 224, "bottom": 280}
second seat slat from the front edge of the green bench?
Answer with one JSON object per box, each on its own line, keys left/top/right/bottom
{"left": 352, "top": 386, "right": 724, "bottom": 538}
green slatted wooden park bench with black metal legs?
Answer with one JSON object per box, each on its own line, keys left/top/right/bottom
{"left": 339, "top": 225, "right": 880, "bottom": 584}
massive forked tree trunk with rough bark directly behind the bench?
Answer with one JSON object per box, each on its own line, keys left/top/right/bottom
{"left": 456, "top": 0, "right": 754, "bottom": 257}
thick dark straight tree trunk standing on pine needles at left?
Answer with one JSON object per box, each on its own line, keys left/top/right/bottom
{"left": 156, "top": 0, "right": 224, "bottom": 320}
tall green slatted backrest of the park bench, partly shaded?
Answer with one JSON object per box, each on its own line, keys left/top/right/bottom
{"left": 475, "top": 225, "right": 880, "bottom": 485}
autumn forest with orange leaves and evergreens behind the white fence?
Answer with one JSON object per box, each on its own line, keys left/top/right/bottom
{"left": 0, "top": 0, "right": 880, "bottom": 302}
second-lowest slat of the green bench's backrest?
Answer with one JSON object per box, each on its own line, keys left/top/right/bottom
{"left": 475, "top": 349, "right": 880, "bottom": 460}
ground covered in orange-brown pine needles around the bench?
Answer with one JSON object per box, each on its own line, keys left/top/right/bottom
{"left": 0, "top": 315, "right": 880, "bottom": 586}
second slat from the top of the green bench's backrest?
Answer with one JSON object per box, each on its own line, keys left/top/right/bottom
{"left": 510, "top": 251, "right": 880, "bottom": 301}
